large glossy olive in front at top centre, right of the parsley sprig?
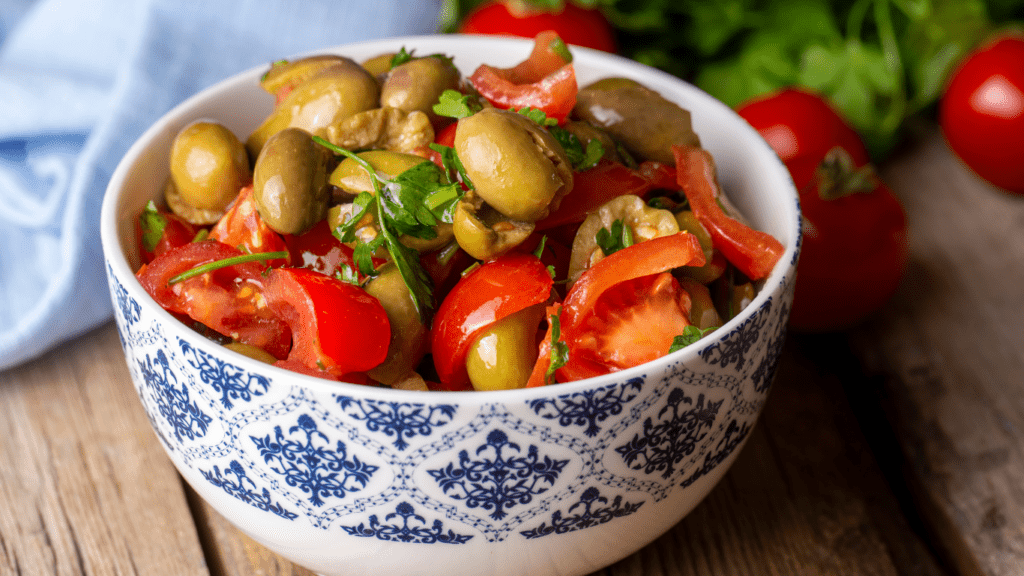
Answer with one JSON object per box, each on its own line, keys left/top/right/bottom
{"left": 455, "top": 108, "right": 572, "bottom": 222}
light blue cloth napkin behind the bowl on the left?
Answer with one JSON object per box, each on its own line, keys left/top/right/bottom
{"left": 0, "top": 0, "right": 440, "bottom": 370}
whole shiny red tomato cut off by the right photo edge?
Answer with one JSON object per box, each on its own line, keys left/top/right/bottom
{"left": 939, "top": 34, "right": 1024, "bottom": 194}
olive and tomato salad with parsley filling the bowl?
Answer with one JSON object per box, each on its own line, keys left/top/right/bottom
{"left": 136, "top": 32, "right": 783, "bottom": 390}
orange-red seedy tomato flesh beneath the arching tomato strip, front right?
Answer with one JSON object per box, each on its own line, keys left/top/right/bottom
{"left": 569, "top": 272, "right": 690, "bottom": 370}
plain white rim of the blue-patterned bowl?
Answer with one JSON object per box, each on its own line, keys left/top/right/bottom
{"left": 100, "top": 34, "right": 802, "bottom": 404}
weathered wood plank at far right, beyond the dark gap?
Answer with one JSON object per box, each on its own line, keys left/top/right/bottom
{"left": 852, "top": 132, "right": 1024, "bottom": 576}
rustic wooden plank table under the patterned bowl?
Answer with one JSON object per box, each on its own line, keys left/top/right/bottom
{"left": 0, "top": 130, "right": 1024, "bottom": 576}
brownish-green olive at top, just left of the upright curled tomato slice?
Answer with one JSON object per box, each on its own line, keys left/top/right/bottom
{"left": 381, "top": 56, "right": 461, "bottom": 127}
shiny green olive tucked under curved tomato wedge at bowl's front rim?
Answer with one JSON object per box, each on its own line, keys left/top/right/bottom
{"left": 466, "top": 303, "right": 544, "bottom": 390}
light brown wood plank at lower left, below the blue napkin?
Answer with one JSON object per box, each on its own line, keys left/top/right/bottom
{"left": 0, "top": 324, "right": 209, "bottom": 576}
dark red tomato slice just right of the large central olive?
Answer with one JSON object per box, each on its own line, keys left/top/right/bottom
{"left": 537, "top": 161, "right": 679, "bottom": 231}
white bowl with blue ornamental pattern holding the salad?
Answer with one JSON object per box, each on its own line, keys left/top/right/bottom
{"left": 101, "top": 36, "right": 800, "bottom": 576}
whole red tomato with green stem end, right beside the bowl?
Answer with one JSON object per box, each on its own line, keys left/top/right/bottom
{"left": 790, "top": 145, "right": 908, "bottom": 332}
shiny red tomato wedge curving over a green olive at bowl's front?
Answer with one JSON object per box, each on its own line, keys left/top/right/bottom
{"left": 430, "top": 252, "right": 554, "bottom": 389}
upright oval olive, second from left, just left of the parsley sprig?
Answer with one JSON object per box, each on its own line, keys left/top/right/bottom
{"left": 253, "top": 128, "right": 331, "bottom": 234}
